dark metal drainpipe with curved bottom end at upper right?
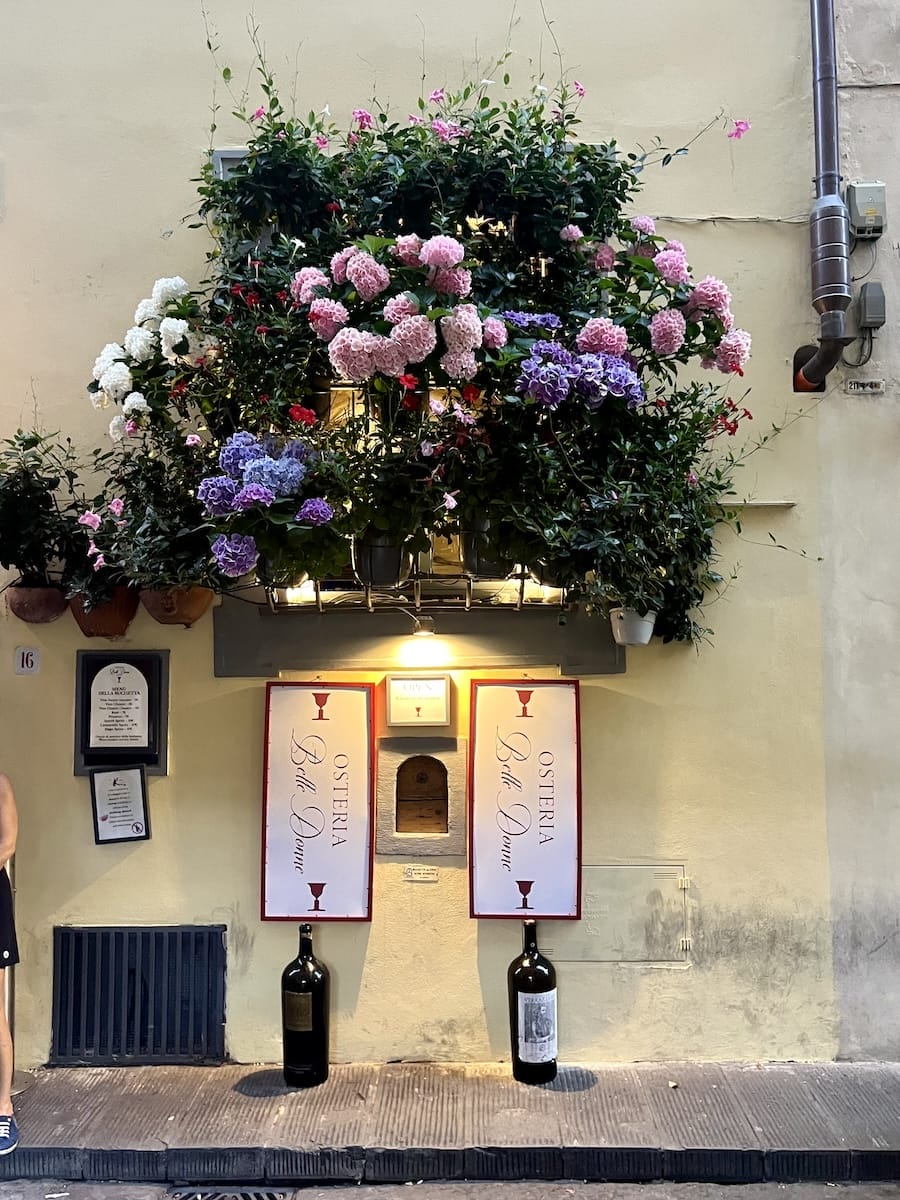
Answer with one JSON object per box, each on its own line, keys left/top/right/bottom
{"left": 793, "top": 0, "right": 853, "bottom": 391}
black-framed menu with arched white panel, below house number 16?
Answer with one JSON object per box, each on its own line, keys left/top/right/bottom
{"left": 74, "top": 650, "right": 169, "bottom": 775}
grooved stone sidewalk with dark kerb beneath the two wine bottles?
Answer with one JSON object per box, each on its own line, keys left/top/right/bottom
{"left": 0, "top": 1063, "right": 900, "bottom": 1186}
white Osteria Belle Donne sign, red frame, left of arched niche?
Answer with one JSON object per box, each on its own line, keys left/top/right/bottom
{"left": 262, "top": 683, "right": 374, "bottom": 920}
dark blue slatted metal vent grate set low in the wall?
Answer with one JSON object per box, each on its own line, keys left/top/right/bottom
{"left": 50, "top": 925, "right": 226, "bottom": 1067}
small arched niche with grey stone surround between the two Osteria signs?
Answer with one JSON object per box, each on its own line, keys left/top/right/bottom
{"left": 376, "top": 737, "right": 467, "bottom": 858}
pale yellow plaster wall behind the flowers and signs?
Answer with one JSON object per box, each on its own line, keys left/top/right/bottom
{"left": 0, "top": 0, "right": 835, "bottom": 1066}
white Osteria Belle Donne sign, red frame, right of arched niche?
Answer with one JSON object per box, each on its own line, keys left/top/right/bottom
{"left": 469, "top": 679, "right": 581, "bottom": 920}
